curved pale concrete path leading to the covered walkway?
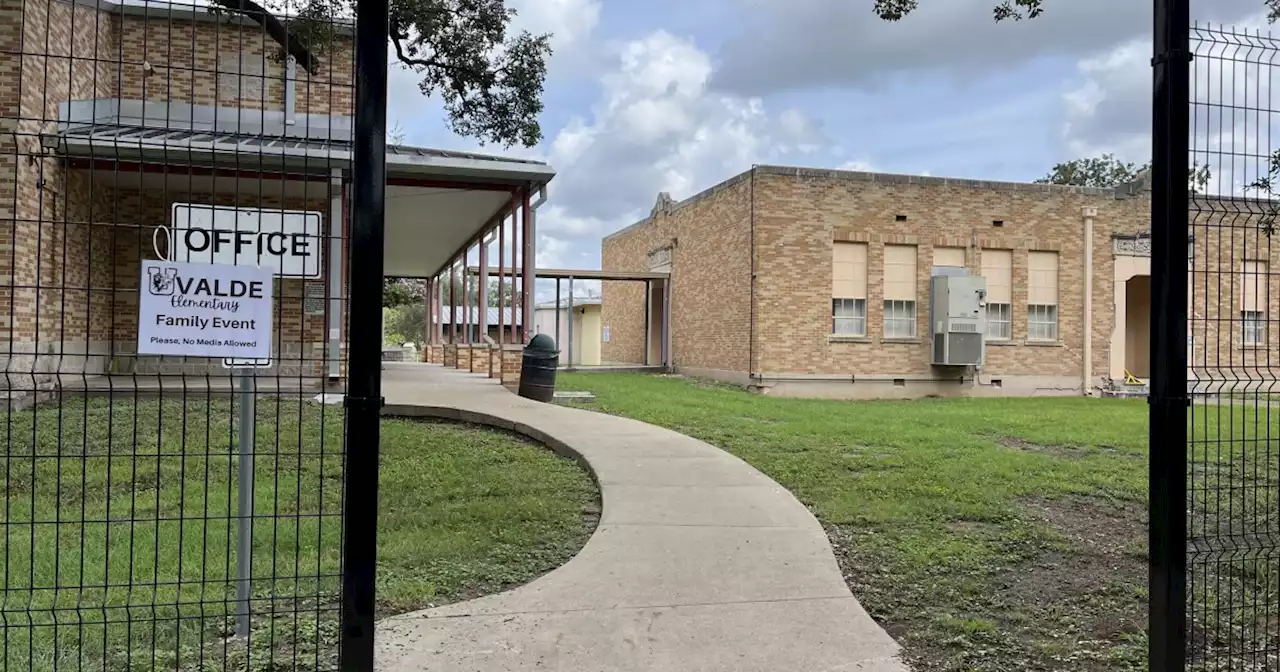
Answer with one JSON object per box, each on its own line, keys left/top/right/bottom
{"left": 376, "top": 364, "right": 906, "bottom": 672}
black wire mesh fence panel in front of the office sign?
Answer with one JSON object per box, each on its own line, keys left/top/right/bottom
{"left": 0, "top": 0, "right": 385, "bottom": 672}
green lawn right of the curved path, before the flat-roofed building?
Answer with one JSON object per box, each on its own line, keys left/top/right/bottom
{"left": 558, "top": 374, "right": 1280, "bottom": 671}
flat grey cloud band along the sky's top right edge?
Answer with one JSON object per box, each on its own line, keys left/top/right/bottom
{"left": 714, "top": 0, "right": 1262, "bottom": 95}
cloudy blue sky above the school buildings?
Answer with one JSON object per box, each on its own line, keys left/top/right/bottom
{"left": 378, "top": 0, "right": 1265, "bottom": 275}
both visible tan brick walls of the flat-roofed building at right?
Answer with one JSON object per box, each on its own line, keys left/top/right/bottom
{"left": 602, "top": 168, "right": 1187, "bottom": 392}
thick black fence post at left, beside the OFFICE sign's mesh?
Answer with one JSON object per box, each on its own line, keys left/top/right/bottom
{"left": 339, "top": 0, "right": 388, "bottom": 672}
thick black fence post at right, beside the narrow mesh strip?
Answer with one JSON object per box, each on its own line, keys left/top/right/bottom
{"left": 1149, "top": 0, "right": 1192, "bottom": 672}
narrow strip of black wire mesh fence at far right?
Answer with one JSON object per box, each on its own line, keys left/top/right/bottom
{"left": 1172, "top": 20, "right": 1280, "bottom": 671}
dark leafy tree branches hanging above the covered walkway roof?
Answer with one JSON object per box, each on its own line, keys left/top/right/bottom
{"left": 214, "top": 0, "right": 552, "bottom": 147}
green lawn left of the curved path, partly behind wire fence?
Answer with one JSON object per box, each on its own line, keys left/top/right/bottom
{"left": 0, "top": 398, "right": 598, "bottom": 672}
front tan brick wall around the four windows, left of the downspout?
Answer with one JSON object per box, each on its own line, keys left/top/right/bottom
{"left": 755, "top": 174, "right": 1115, "bottom": 378}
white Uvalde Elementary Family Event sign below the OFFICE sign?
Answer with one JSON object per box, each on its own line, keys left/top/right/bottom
{"left": 138, "top": 261, "right": 273, "bottom": 360}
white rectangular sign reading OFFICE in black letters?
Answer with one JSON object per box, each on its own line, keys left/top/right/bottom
{"left": 168, "top": 204, "right": 324, "bottom": 278}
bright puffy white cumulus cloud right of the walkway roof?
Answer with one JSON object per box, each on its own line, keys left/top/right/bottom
{"left": 549, "top": 31, "right": 823, "bottom": 227}
